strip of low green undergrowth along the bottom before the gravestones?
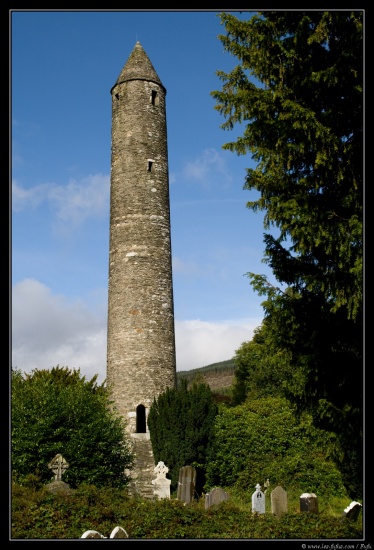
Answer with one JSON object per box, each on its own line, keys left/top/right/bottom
{"left": 10, "top": 486, "right": 363, "bottom": 540}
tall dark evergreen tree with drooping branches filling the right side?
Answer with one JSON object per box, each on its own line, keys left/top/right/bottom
{"left": 212, "top": 11, "right": 363, "bottom": 498}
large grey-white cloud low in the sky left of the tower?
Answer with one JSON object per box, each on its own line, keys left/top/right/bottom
{"left": 12, "top": 279, "right": 106, "bottom": 381}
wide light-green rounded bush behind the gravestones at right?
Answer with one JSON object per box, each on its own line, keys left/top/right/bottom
{"left": 207, "top": 397, "right": 346, "bottom": 496}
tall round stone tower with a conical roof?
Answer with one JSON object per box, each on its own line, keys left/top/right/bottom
{"left": 107, "top": 42, "right": 176, "bottom": 494}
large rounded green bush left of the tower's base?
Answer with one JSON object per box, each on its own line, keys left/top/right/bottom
{"left": 11, "top": 366, "right": 133, "bottom": 488}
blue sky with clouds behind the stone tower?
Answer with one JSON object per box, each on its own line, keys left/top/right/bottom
{"left": 10, "top": 11, "right": 273, "bottom": 380}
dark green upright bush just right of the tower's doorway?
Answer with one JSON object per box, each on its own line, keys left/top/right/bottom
{"left": 148, "top": 379, "right": 218, "bottom": 492}
